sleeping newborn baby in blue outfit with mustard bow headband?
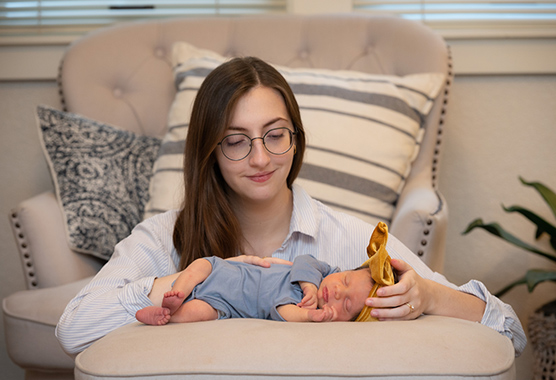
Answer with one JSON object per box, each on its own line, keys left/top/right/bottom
{"left": 136, "top": 223, "right": 393, "bottom": 325}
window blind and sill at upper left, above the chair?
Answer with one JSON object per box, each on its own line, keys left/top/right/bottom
{"left": 0, "top": 0, "right": 286, "bottom": 36}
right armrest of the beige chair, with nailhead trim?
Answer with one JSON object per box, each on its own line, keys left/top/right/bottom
{"left": 390, "top": 180, "right": 448, "bottom": 273}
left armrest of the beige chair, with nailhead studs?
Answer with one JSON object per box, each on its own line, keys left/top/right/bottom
{"left": 10, "top": 192, "right": 102, "bottom": 289}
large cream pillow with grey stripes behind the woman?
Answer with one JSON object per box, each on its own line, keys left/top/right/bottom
{"left": 145, "top": 42, "right": 445, "bottom": 223}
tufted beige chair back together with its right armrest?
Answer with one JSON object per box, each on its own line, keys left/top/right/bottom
{"left": 59, "top": 14, "right": 452, "bottom": 270}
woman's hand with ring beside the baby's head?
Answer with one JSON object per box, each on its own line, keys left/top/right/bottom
{"left": 365, "top": 259, "right": 431, "bottom": 321}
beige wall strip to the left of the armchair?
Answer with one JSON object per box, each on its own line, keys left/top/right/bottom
{"left": 0, "top": 81, "right": 60, "bottom": 380}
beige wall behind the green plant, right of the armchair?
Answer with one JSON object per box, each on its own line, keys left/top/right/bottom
{"left": 439, "top": 75, "right": 556, "bottom": 380}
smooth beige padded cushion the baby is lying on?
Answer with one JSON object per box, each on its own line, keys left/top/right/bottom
{"left": 75, "top": 316, "right": 515, "bottom": 380}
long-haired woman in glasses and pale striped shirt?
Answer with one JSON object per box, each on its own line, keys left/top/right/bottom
{"left": 57, "top": 58, "right": 526, "bottom": 354}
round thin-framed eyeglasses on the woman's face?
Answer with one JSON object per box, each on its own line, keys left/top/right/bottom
{"left": 218, "top": 127, "right": 297, "bottom": 161}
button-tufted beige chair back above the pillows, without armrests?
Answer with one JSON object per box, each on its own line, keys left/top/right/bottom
{"left": 60, "top": 15, "right": 448, "bottom": 136}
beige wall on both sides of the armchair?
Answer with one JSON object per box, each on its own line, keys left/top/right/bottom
{"left": 0, "top": 60, "right": 556, "bottom": 380}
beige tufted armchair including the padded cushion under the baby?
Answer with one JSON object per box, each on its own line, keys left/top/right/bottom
{"left": 3, "top": 15, "right": 514, "bottom": 379}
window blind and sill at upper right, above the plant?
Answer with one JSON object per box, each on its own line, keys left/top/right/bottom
{"left": 353, "top": 0, "right": 556, "bottom": 36}
